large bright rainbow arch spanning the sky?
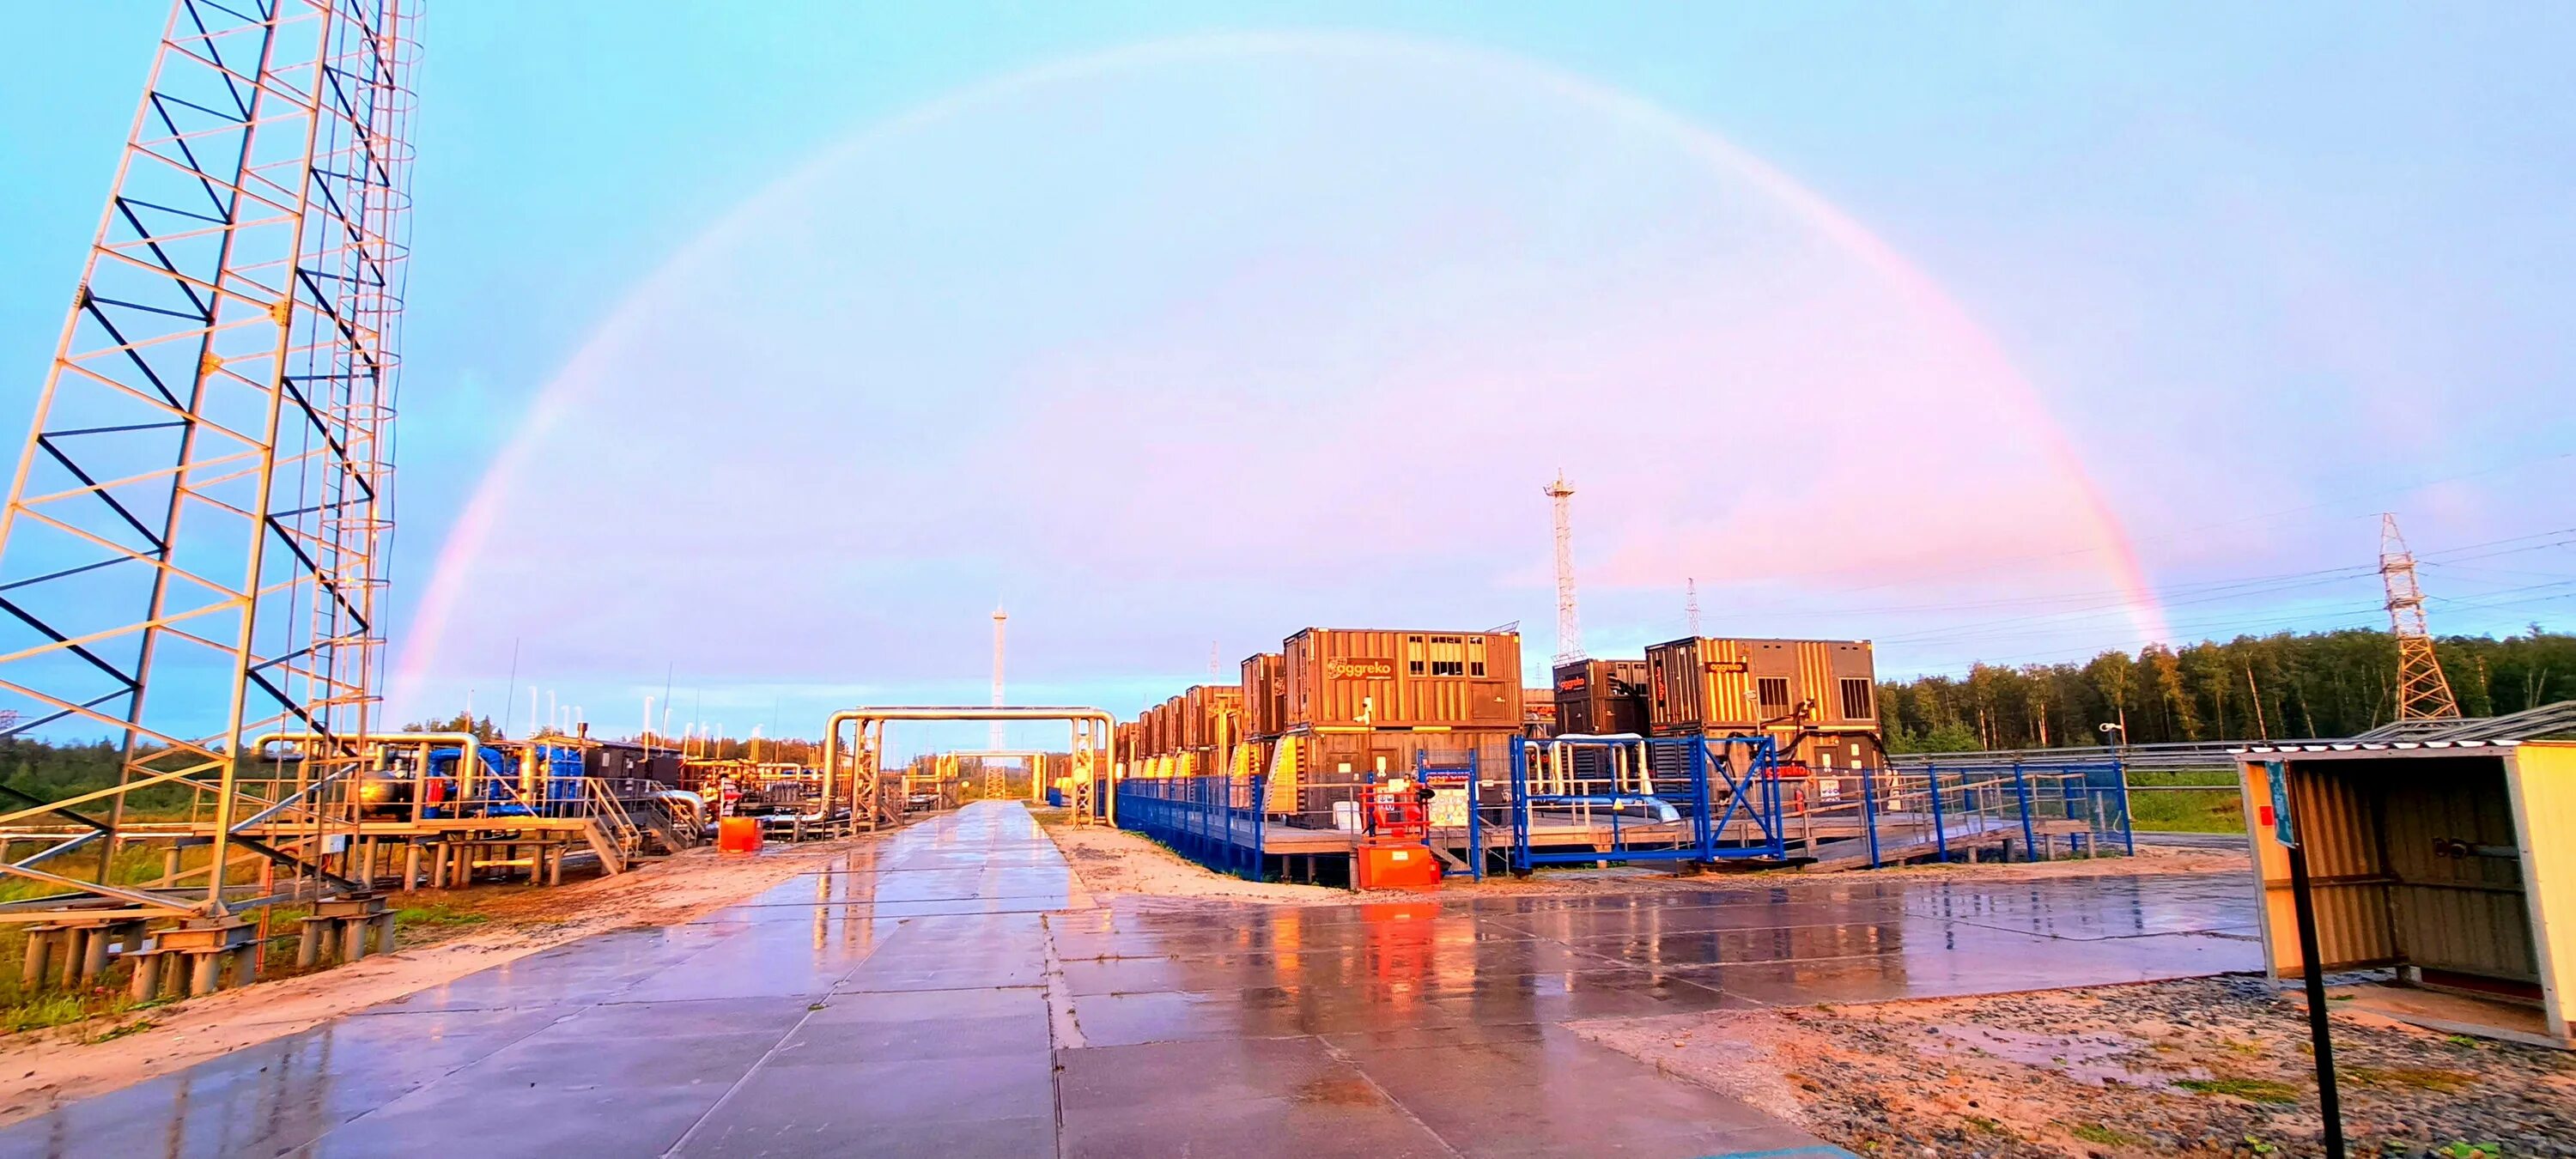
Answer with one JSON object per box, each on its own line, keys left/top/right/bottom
{"left": 392, "top": 31, "right": 2166, "bottom": 708}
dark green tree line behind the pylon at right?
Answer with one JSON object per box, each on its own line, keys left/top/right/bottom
{"left": 1878, "top": 623, "right": 2576, "bottom": 752}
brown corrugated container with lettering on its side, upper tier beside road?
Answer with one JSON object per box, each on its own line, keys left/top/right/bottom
{"left": 1280, "top": 628, "right": 1522, "bottom": 731}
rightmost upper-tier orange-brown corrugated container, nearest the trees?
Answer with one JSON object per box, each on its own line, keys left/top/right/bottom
{"left": 1646, "top": 636, "right": 1878, "bottom": 734}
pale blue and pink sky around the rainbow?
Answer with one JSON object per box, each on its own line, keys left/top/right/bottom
{"left": 0, "top": 3, "right": 2576, "bottom": 752}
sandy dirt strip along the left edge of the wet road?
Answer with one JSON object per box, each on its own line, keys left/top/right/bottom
{"left": 0, "top": 842, "right": 850, "bottom": 1126}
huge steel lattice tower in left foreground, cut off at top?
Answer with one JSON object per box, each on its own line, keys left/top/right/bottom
{"left": 0, "top": 0, "right": 417, "bottom": 914}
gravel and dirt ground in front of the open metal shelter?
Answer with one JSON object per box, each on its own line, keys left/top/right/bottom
{"left": 1577, "top": 976, "right": 2576, "bottom": 1159}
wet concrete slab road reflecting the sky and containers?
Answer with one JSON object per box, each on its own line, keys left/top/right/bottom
{"left": 0, "top": 804, "right": 2257, "bottom": 1159}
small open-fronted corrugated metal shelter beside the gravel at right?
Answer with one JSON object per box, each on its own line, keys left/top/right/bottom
{"left": 2236, "top": 703, "right": 2576, "bottom": 1046}
